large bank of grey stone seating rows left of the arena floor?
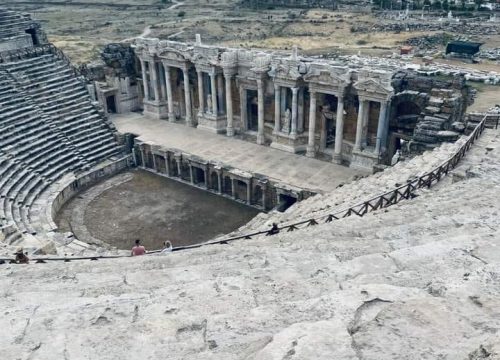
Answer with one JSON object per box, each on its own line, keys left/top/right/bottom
{"left": 0, "top": 53, "right": 122, "bottom": 244}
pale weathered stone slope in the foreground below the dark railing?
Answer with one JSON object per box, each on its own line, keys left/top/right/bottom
{"left": 0, "top": 130, "right": 500, "bottom": 360}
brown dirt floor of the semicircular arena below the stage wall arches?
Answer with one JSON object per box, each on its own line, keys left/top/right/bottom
{"left": 57, "top": 170, "right": 258, "bottom": 250}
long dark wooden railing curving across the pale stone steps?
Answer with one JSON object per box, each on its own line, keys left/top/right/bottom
{"left": 0, "top": 114, "right": 489, "bottom": 264}
